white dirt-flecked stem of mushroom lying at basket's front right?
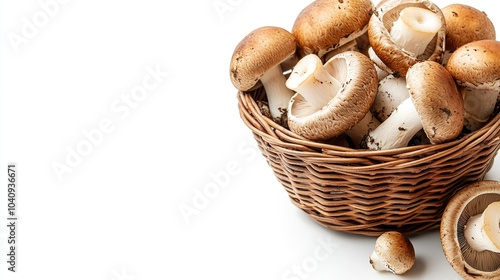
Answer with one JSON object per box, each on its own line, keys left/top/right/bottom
{"left": 365, "top": 98, "right": 423, "bottom": 150}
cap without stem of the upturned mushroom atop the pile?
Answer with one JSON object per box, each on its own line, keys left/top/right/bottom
{"left": 368, "top": 0, "right": 446, "bottom": 76}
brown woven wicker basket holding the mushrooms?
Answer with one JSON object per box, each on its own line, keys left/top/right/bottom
{"left": 238, "top": 89, "right": 500, "bottom": 236}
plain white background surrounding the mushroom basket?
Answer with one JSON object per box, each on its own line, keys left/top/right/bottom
{"left": 0, "top": 0, "right": 500, "bottom": 280}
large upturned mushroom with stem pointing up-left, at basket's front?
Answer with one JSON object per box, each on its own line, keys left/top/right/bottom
{"left": 286, "top": 51, "right": 378, "bottom": 140}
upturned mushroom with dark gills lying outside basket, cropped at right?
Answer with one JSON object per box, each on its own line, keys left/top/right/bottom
{"left": 440, "top": 180, "right": 500, "bottom": 279}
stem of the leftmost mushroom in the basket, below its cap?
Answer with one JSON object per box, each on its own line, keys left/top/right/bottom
{"left": 260, "top": 65, "right": 294, "bottom": 118}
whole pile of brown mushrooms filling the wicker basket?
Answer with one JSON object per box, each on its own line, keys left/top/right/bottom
{"left": 229, "top": 0, "right": 500, "bottom": 150}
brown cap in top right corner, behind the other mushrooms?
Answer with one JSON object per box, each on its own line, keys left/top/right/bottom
{"left": 441, "top": 3, "right": 496, "bottom": 52}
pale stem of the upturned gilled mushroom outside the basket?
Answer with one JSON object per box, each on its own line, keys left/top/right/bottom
{"left": 464, "top": 201, "right": 500, "bottom": 253}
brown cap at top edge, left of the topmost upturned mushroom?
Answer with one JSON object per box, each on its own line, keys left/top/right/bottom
{"left": 292, "top": 0, "right": 373, "bottom": 57}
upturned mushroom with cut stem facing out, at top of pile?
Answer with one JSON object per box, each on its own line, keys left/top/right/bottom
{"left": 368, "top": 0, "right": 446, "bottom": 76}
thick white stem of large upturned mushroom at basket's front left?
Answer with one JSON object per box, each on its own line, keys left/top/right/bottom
{"left": 286, "top": 54, "right": 341, "bottom": 110}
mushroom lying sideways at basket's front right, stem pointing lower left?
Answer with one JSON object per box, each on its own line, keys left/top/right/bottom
{"left": 364, "top": 60, "right": 464, "bottom": 150}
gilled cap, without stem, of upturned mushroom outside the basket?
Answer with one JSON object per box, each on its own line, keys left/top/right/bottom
{"left": 440, "top": 180, "right": 500, "bottom": 279}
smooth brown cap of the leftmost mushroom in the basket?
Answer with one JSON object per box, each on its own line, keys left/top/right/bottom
{"left": 229, "top": 26, "right": 297, "bottom": 91}
